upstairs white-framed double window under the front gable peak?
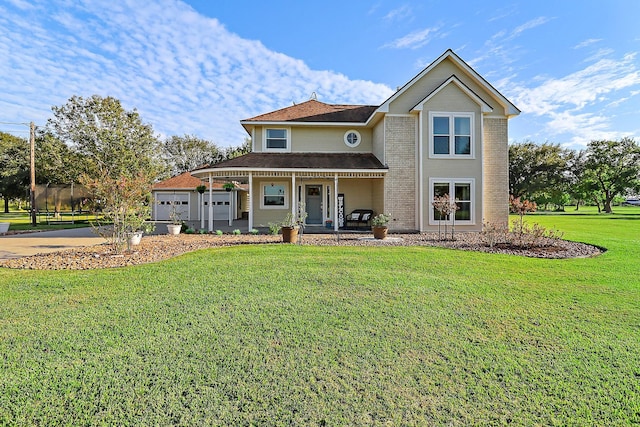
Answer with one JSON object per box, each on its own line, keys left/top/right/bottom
{"left": 429, "top": 112, "right": 473, "bottom": 157}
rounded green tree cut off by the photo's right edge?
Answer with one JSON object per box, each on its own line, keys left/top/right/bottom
{"left": 584, "top": 138, "right": 640, "bottom": 213}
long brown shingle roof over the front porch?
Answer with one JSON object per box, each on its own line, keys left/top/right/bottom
{"left": 196, "top": 153, "right": 387, "bottom": 169}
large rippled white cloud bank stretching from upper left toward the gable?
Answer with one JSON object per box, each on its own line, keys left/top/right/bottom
{"left": 0, "top": 0, "right": 392, "bottom": 145}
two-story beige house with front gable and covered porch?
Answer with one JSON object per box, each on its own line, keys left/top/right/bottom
{"left": 192, "top": 50, "right": 520, "bottom": 231}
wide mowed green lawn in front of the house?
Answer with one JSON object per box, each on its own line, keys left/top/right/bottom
{"left": 0, "top": 208, "right": 640, "bottom": 426}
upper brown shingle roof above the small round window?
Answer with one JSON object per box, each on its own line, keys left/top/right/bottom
{"left": 243, "top": 99, "right": 378, "bottom": 123}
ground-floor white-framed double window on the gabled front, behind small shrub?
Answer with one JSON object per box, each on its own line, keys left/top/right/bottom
{"left": 429, "top": 178, "right": 475, "bottom": 225}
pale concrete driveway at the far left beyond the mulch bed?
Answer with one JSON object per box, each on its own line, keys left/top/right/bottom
{"left": 0, "top": 227, "right": 105, "bottom": 259}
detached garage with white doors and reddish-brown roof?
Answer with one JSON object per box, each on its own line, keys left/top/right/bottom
{"left": 152, "top": 172, "right": 247, "bottom": 229}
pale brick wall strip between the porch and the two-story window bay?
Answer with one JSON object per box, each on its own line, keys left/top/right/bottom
{"left": 384, "top": 115, "right": 418, "bottom": 230}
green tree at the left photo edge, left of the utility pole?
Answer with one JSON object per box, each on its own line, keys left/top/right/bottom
{"left": 0, "top": 132, "right": 29, "bottom": 213}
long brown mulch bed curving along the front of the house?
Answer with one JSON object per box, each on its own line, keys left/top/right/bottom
{"left": 0, "top": 233, "right": 603, "bottom": 270}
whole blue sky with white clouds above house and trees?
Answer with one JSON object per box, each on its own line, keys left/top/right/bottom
{"left": 0, "top": 0, "right": 640, "bottom": 148}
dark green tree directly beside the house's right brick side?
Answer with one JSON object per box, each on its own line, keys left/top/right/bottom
{"left": 509, "top": 141, "right": 572, "bottom": 200}
